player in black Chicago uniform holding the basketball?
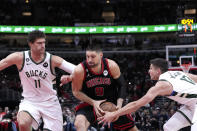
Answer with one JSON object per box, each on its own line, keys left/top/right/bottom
{"left": 63, "top": 45, "right": 137, "bottom": 131}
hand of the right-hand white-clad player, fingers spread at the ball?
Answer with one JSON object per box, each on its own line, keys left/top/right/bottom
{"left": 97, "top": 111, "right": 117, "bottom": 128}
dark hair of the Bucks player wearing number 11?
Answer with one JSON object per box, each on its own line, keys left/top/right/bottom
{"left": 27, "top": 30, "right": 46, "bottom": 43}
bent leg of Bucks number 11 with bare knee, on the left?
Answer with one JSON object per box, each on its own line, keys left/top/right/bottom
{"left": 17, "top": 101, "right": 40, "bottom": 131}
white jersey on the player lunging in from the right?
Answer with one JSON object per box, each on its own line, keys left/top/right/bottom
{"left": 159, "top": 71, "right": 197, "bottom": 106}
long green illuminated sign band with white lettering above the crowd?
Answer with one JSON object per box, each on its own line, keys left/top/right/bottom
{"left": 0, "top": 24, "right": 197, "bottom": 34}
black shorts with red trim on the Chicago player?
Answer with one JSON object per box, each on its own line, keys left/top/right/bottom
{"left": 75, "top": 103, "right": 135, "bottom": 131}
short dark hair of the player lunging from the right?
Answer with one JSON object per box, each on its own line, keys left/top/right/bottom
{"left": 150, "top": 58, "right": 168, "bottom": 73}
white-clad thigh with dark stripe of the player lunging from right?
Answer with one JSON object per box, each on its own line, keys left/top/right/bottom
{"left": 163, "top": 106, "right": 192, "bottom": 131}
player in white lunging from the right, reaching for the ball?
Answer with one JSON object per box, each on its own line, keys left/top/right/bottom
{"left": 98, "top": 58, "right": 197, "bottom": 131}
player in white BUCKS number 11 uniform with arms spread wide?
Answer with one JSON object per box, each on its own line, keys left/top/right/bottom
{"left": 0, "top": 30, "right": 75, "bottom": 131}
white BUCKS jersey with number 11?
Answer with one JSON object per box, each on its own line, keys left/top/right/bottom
{"left": 19, "top": 51, "right": 57, "bottom": 102}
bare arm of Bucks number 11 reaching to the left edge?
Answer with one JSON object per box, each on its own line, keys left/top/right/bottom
{"left": 0, "top": 52, "right": 23, "bottom": 70}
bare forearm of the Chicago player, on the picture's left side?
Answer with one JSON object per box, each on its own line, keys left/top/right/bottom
{"left": 73, "top": 91, "right": 94, "bottom": 105}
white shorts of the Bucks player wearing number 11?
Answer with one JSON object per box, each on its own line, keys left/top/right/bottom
{"left": 19, "top": 97, "right": 63, "bottom": 131}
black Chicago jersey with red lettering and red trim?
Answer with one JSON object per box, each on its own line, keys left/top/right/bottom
{"left": 81, "top": 58, "right": 118, "bottom": 103}
